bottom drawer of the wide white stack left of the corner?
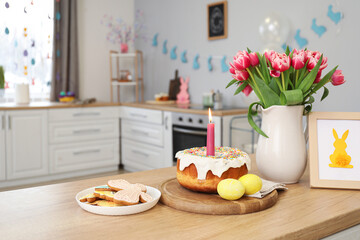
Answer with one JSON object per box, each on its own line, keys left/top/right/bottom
{"left": 50, "top": 139, "right": 120, "bottom": 173}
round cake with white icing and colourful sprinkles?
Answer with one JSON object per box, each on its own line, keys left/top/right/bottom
{"left": 175, "top": 147, "right": 251, "bottom": 193}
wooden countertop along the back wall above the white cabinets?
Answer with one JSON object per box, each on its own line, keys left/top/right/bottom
{"left": 0, "top": 102, "right": 248, "bottom": 116}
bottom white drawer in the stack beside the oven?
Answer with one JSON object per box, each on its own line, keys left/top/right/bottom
{"left": 121, "top": 139, "right": 164, "bottom": 171}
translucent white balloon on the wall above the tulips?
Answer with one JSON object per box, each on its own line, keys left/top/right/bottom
{"left": 259, "top": 12, "right": 290, "bottom": 45}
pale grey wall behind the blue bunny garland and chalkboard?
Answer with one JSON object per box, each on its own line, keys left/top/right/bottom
{"left": 135, "top": 0, "right": 360, "bottom": 111}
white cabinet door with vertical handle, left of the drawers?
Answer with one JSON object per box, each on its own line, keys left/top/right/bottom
{"left": 5, "top": 110, "right": 49, "bottom": 180}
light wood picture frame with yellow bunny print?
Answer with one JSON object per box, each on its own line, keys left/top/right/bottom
{"left": 308, "top": 112, "right": 360, "bottom": 189}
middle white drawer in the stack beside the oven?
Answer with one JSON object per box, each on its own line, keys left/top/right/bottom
{"left": 121, "top": 120, "right": 164, "bottom": 147}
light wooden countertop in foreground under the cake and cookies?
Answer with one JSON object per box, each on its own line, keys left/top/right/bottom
{"left": 0, "top": 156, "right": 360, "bottom": 240}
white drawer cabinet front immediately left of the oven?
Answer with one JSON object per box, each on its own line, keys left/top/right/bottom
{"left": 120, "top": 107, "right": 173, "bottom": 171}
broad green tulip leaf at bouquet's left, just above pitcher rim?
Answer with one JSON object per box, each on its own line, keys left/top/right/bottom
{"left": 253, "top": 75, "right": 280, "bottom": 108}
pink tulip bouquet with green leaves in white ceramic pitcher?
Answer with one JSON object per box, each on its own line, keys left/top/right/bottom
{"left": 227, "top": 47, "right": 345, "bottom": 183}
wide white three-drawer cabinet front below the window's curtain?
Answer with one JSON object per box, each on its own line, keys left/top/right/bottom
{"left": 49, "top": 107, "right": 120, "bottom": 176}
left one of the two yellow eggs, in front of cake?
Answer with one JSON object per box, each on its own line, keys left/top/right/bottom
{"left": 217, "top": 178, "right": 245, "bottom": 200}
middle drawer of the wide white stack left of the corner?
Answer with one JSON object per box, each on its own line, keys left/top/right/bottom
{"left": 49, "top": 118, "right": 119, "bottom": 143}
